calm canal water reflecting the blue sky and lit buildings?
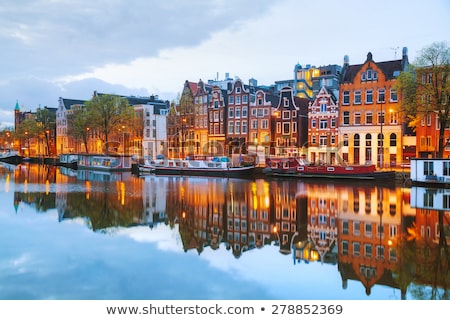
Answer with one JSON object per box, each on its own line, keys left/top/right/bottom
{"left": 0, "top": 164, "right": 449, "bottom": 300}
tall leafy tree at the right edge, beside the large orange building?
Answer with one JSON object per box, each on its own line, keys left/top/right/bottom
{"left": 397, "top": 42, "right": 450, "bottom": 157}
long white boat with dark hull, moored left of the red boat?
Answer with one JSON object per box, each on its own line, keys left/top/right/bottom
{"left": 139, "top": 156, "right": 255, "bottom": 177}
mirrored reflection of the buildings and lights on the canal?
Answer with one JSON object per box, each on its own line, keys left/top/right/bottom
{"left": 1, "top": 164, "right": 450, "bottom": 299}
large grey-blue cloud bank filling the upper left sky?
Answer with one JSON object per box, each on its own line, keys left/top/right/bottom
{"left": 0, "top": 0, "right": 271, "bottom": 78}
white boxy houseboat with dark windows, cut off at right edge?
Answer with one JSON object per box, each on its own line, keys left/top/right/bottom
{"left": 410, "top": 158, "right": 450, "bottom": 188}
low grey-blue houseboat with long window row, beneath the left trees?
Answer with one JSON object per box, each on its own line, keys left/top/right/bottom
{"left": 77, "top": 153, "right": 133, "bottom": 171}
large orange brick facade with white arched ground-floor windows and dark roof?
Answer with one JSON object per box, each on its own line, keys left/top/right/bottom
{"left": 339, "top": 48, "right": 408, "bottom": 168}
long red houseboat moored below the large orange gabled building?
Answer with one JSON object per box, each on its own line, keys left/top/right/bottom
{"left": 264, "top": 157, "right": 395, "bottom": 180}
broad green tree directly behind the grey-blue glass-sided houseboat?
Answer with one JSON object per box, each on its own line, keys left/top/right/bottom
{"left": 86, "top": 94, "right": 135, "bottom": 153}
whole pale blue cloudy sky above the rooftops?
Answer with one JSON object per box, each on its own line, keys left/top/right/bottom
{"left": 0, "top": 0, "right": 450, "bottom": 126}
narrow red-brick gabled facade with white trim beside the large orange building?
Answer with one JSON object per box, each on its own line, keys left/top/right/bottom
{"left": 308, "top": 87, "right": 340, "bottom": 164}
